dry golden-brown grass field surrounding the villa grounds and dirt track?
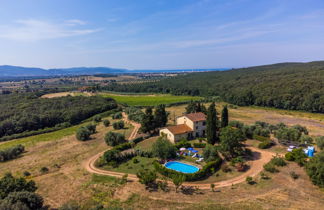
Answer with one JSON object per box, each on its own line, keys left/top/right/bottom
{"left": 0, "top": 104, "right": 324, "bottom": 209}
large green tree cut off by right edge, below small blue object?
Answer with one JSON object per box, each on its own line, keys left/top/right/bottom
{"left": 306, "top": 151, "right": 324, "bottom": 188}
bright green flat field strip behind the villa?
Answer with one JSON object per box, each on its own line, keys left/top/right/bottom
{"left": 99, "top": 93, "right": 202, "bottom": 106}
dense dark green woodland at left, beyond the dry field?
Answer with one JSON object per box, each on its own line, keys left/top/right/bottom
{"left": 0, "top": 93, "right": 117, "bottom": 137}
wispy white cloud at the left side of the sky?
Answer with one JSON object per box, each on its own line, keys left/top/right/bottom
{"left": 0, "top": 19, "right": 99, "bottom": 41}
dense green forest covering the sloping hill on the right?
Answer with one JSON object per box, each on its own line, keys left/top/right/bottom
{"left": 104, "top": 61, "right": 324, "bottom": 113}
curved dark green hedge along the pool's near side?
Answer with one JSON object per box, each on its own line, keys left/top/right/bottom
{"left": 153, "top": 158, "right": 222, "bottom": 181}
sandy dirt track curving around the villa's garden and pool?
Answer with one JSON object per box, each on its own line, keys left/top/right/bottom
{"left": 85, "top": 113, "right": 275, "bottom": 189}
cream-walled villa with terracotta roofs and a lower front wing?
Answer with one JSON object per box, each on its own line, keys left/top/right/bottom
{"left": 160, "top": 112, "right": 206, "bottom": 143}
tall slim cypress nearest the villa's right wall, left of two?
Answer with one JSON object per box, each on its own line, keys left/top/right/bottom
{"left": 206, "top": 102, "right": 218, "bottom": 144}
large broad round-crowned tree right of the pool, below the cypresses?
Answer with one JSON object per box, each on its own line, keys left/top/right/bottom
{"left": 220, "top": 127, "right": 245, "bottom": 159}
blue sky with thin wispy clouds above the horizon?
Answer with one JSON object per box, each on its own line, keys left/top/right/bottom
{"left": 0, "top": 0, "right": 324, "bottom": 69}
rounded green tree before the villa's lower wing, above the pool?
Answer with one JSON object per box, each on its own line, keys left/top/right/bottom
{"left": 152, "top": 137, "right": 177, "bottom": 160}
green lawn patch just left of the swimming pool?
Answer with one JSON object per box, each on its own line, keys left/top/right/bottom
{"left": 103, "top": 156, "right": 155, "bottom": 174}
